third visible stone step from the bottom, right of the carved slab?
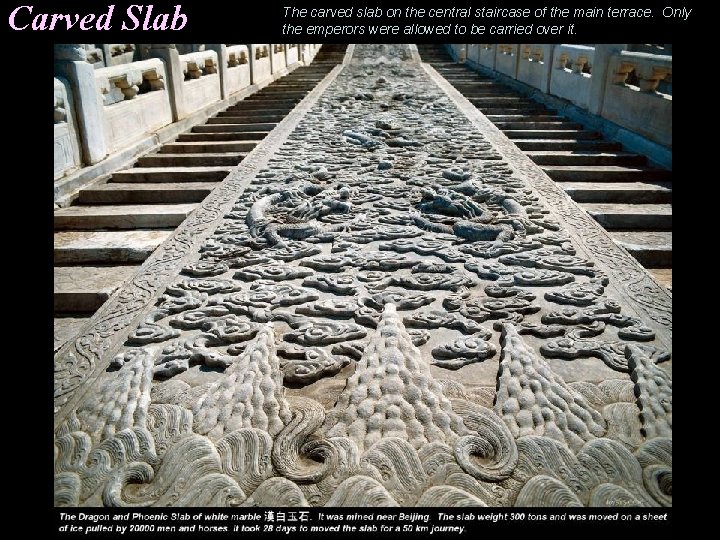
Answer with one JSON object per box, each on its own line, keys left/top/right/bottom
{"left": 580, "top": 203, "right": 672, "bottom": 230}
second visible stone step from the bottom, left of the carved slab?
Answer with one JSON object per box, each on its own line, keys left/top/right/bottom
{"left": 53, "top": 266, "right": 137, "bottom": 313}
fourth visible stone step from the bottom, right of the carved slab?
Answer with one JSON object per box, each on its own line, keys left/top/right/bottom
{"left": 557, "top": 182, "right": 672, "bottom": 204}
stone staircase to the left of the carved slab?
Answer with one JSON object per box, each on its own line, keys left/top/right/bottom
{"left": 54, "top": 45, "right": 347, "bottom": 350}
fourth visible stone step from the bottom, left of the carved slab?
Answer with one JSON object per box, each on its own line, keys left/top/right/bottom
{"left": 54, "top": 203, "right": 198, "bottom": 230}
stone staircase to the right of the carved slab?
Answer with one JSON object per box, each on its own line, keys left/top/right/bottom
{"left": 418, "top": 44, "right": 672, "bottom": 288}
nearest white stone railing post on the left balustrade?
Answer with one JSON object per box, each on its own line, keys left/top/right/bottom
{"left": 55, "top": 44, "right": 107, "bottom": 165}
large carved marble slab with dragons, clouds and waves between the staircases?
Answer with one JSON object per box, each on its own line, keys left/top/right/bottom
{"left": 55, "top": 45, "right": 672, "bottom": 506}
